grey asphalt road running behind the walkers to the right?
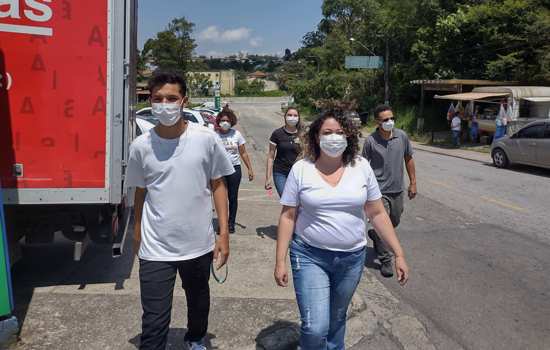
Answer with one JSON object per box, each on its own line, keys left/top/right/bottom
{"left": 234, "top": 104, "right": 550, "bottom": 350}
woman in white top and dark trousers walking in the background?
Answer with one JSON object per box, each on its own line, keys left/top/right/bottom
{"left": 216, "top": 106, "right": 254, "bottom": 233}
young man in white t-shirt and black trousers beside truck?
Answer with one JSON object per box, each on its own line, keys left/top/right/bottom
{"left": 126, "top": 73, "right": 234, "bottom": 350}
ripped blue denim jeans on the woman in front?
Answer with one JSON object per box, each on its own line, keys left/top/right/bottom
{"left": 290, "top": 235, "right": 366, "bottom": 350}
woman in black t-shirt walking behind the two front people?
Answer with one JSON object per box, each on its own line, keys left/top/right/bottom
{"left": 265, "top": 107, "right": 300, "bottom": 197}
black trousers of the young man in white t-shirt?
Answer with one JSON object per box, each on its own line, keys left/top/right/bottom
{"left": 139, "top": 252, "right": 213, "bottom": 350}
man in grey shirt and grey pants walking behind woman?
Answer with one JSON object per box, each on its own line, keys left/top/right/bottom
{"left": 363, "top": 105, "right": 416, "bottom": 277}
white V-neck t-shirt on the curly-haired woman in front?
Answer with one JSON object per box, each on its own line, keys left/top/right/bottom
{"left": 281, "top": 157, "right": 382, "bottom": 252}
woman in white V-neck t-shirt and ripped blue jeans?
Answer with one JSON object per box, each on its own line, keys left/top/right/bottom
{"left": 274, "top": 112, "right": 409, "bottom": 350}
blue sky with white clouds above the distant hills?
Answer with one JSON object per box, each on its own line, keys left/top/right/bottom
{"left": 138, "top": 0, "right": 322, "bottom": 56}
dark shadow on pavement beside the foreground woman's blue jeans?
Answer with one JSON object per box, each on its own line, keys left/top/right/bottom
{"left": 256, "top": 320, "right": 300, "bottom": 350}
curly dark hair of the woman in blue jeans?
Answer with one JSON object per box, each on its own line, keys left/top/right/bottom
{"left": 303, "top": 111, "right": 361, "bottom": 166}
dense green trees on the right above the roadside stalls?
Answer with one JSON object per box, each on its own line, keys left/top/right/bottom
{"left": 277, "top": 0, "right": 550, "bottom": 132}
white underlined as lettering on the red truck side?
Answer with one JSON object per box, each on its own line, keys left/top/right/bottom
{"left": 0, "top": 0, "right": 53, "bottom": 36}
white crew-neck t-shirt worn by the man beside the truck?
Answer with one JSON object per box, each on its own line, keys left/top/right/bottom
{"left": 126, "top": 123, "right": 234, "bottom": 261}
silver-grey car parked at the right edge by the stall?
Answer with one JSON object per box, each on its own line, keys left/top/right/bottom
{"left": 491, "top": 119, "right": 550, "bottom": 169}
